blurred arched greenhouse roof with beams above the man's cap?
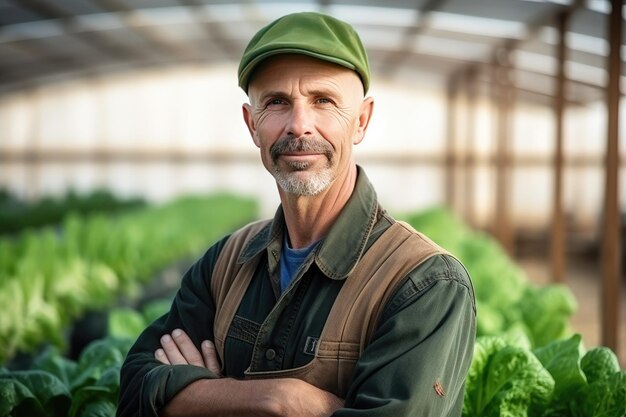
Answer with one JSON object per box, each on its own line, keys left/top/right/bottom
{"left": 0, "top": 0, "right": 626, "bottom": 103}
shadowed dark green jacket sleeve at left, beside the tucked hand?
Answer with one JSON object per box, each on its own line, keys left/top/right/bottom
{"left": 117, "top": 238, "right": 226, "bottom": 417}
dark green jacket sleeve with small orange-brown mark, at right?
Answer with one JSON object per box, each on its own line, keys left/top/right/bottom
{"left": 333, "top": 255, "right": 476, "bottom": 417}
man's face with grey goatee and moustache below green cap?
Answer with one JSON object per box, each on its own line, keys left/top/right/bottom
{"left": 243, "top": 55, "right": 372, "bottom": 196}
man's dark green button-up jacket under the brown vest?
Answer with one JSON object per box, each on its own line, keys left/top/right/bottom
{"left": 118, "top": 169, "right": 476, "bottom": 417}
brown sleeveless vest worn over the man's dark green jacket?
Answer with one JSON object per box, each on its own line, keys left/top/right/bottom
{"left": 211, "top": 221, "right": 447, "bottom": 398}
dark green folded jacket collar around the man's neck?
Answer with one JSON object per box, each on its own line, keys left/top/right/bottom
{"left": 237, "top": 166, "right": 378, "bottom": 280}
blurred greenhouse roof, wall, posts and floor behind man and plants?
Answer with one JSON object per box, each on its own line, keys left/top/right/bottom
{"left": 0, "top": 0, "right": 626, "bottom": 364}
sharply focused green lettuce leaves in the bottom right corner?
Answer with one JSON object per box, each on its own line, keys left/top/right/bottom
{"left": 463, "top": 333, "right": 626, "bottom": 417}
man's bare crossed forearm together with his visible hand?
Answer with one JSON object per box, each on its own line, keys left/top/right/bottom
{"left": 155, "top": 329, "right": 343, "bottom": 417}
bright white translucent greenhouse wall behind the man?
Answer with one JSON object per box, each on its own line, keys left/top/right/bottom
{"left": 0, "top": 65, "right": 626, "bottom": 234}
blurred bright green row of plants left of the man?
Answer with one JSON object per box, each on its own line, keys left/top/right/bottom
{"left": 0, "top": 194, "right": 257, "bottom": 364}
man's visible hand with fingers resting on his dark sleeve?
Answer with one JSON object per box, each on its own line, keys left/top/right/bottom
{"left": 154, "top": 329, "right": 222, "bottom": 378}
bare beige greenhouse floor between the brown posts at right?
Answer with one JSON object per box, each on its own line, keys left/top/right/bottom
{"left": 516, "top": 257, "right": 626, "bottom": 369}
